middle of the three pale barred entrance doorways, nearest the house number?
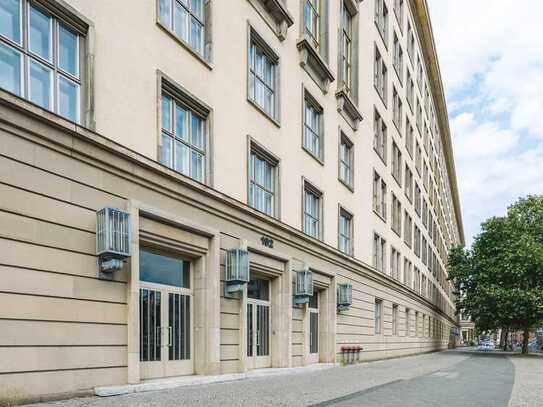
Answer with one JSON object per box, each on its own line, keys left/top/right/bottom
{"left": 247, "top": 278, "right": 271, "bottom": 369}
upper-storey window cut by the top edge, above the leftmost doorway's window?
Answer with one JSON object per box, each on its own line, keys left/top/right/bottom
{"left": 158, "top": 0, "right": 209, "bottom": 57}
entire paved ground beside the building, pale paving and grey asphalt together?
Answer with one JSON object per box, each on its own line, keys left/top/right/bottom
{"left": 26, "top": 351, "right": 543, "bottom": 407}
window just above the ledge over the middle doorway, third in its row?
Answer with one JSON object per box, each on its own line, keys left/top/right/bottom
{"left": 249, "top": 145, "right": 278, "bottom": 216}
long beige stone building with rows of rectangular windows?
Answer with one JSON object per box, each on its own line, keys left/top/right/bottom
{"left": 0, "top": 0, "right": 464, "bottom": 397}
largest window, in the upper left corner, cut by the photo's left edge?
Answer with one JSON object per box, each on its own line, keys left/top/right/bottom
{"left": 0, "top": 0, "right": 84, "bottom": 123}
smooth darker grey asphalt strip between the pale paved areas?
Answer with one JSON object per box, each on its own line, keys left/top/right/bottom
{"left": 314, "top": 354, "right": 516, "bottom": 407}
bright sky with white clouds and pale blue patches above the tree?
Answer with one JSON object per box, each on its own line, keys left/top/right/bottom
{"left": 428, "top": 0, "right": 543, "bottom": 246}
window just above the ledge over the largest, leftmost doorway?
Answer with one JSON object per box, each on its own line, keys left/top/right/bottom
{"left": 160, "top": 91, "right": 208, "bottom": 182}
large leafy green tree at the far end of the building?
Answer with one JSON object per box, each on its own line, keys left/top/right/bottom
{"left": 448, "top": 196, "right": 543, "bottom": 353}
